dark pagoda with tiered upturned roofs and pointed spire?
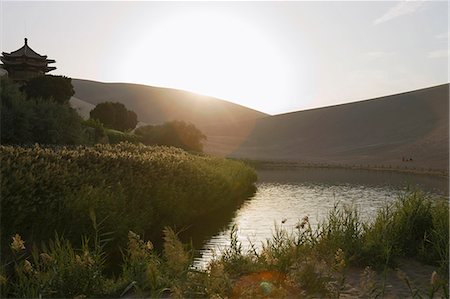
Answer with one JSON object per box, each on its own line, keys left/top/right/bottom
{"left": 0, "top": 38, "right": 56, "bottom": 81}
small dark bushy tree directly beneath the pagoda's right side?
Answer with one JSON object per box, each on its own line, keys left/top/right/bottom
{"left": 23, "top": 75, "right": 75, "bottom": 104}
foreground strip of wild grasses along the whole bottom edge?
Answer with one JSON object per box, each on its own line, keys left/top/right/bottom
{"left": 0, "top": 192, "right": 449, "bottom": 298}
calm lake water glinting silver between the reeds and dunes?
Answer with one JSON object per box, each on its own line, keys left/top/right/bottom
{"left": 190, "top": 169, "right": 448, "bottom": 267}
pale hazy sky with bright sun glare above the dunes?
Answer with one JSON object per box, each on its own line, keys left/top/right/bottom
{"left": 0, "top": 0, "right": 449, "bottom": 114}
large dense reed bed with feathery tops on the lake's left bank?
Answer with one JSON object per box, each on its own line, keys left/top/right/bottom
{"left": 0, "top": 143, "right": 256, "bottom": 258}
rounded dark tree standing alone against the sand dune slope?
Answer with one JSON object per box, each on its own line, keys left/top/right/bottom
{"left": 90, "top": 102, "right": 137, "bottom": 132}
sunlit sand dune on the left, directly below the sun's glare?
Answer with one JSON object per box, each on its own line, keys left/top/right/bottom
{"left": 71, "top": 79, "right": 267, "bottom": 155}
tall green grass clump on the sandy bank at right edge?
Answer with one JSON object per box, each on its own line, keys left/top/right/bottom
{"left": 360, "top": 191, "right": 449, "bottom": 269}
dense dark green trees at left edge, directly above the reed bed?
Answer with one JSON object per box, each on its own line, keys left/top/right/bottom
{"left": 0, "top": 79, "right": 85, "bottom": 144}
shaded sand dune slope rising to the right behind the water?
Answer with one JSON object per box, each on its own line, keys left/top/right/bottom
{"left": 231, "top": 84, "right": 449, "bottom": 169}
